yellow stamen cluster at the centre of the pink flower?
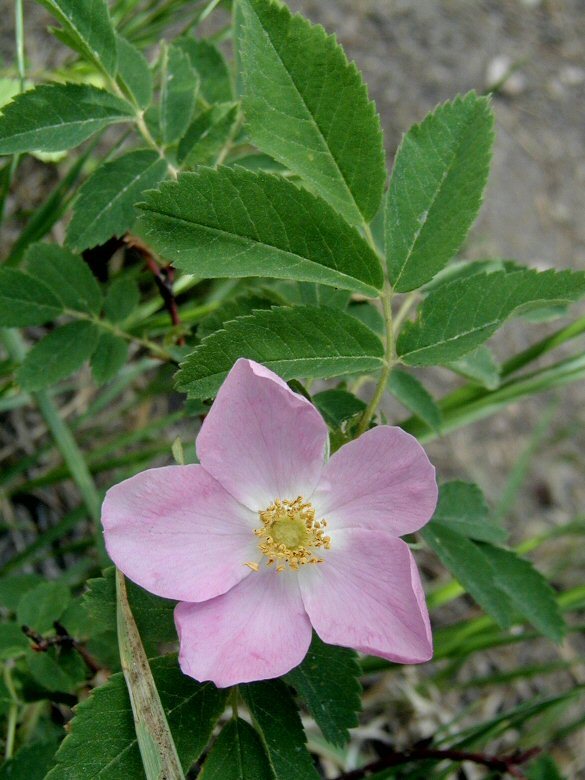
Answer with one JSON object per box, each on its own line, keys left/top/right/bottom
{"left": 246, "top": 496, "right": 331, "bottom": 572}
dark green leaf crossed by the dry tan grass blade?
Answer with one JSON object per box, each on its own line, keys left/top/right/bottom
{"left": 47, "top": 656, "right": 227, "bottom": 780}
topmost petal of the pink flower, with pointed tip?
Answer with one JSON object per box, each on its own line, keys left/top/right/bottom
{"left": 197, "top": 359, "right": 327, "bottom": 511}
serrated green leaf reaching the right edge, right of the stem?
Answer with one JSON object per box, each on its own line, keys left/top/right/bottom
{"left": 397, "top": 269, "right": 585, "bottom": 366}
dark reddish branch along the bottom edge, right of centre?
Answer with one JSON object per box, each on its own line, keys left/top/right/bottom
{"left": 337, "top": 746, "right": 540, "bottom": 780}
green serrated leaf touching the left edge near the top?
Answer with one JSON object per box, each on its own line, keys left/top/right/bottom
{"left": 0, "top": 84, "right": 133, "bottom": 154}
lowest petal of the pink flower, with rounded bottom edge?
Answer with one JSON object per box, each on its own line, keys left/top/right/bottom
{"left": 175, "top": 567, "right": 311, "bottom": 688}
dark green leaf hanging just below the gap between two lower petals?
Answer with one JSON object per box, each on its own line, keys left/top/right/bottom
{"left": 286, "top": 634, "right": 362, "bottom": 747}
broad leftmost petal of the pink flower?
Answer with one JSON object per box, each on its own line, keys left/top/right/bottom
{"left": 102, "top": 465, "right": 261, "bottom": 601}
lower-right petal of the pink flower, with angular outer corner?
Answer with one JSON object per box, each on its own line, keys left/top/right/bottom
{"left": 299, "top": 528, "right": 433, "bottom": 664}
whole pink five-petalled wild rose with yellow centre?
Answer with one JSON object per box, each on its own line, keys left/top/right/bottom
{"left": 102, "top": 359, "right": 437, "bottom": 687}
